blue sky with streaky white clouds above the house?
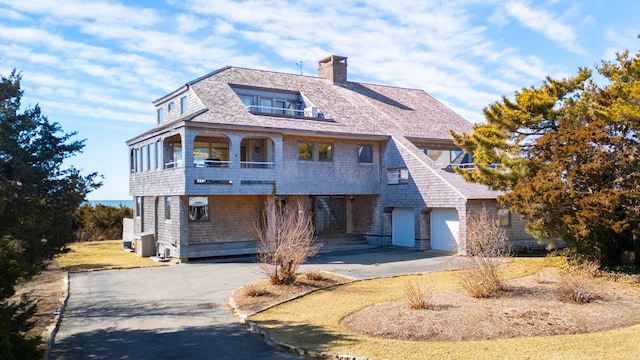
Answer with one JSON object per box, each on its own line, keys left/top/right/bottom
{"left": 0, "top": 0, "right": 640, "bottom": 200}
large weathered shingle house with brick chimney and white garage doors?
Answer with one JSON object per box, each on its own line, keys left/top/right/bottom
{"left": 127, "top": 55, "right": 535, "bottom": 258}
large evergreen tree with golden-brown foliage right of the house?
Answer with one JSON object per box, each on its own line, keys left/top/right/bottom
{"left": 453, "top": 52, "right": 640, "bottom": 262}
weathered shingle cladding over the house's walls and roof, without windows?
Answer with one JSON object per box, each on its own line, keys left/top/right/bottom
{"left": 128, "top": 63, "right": 548, "bottom": 258}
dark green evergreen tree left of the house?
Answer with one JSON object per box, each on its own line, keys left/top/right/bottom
{"left": 0, "top": 70, "right": 101, "bottom": 359}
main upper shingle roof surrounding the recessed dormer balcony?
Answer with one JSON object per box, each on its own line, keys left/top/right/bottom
{"left": 185, "top": 67, "right": 471, "bottom": 139}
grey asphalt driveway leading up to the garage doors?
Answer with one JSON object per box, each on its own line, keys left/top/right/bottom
{"left": 50, "top": 248, "right": 467, "bottom": 360}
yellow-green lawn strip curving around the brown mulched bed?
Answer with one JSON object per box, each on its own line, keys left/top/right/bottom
{"left": 250, "top": 258, "right": 640, "bottom": 360}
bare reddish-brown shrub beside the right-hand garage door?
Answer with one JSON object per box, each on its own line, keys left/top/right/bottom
{"left": 462, "top": 207, "right": 510, "bottom": 298}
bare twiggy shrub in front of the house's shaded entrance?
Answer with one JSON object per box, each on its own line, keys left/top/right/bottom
{"left": 254, "top": 198, "right": 321, "bottom": 285}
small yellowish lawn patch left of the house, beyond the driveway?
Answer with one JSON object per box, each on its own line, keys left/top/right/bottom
{"left": 56, "top": 240, "right": 166, "bottom": 272}
